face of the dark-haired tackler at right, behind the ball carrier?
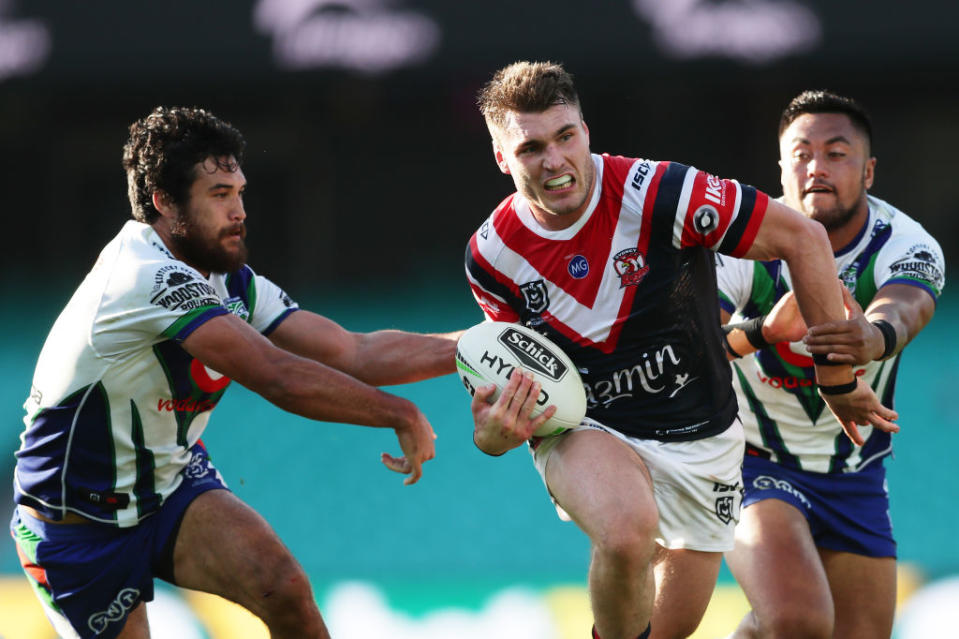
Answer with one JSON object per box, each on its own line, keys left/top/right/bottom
{"left": 779, "top": 113, "right": 876, "bottom": 231}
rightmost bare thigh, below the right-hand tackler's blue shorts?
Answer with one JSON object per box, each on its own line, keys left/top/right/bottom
{"left": 820, "top": 550, "right": 896, "bottom": 639}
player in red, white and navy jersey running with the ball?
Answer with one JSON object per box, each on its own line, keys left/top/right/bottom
{"left": 466, "top": 62, "right": 896, "bottom": 639}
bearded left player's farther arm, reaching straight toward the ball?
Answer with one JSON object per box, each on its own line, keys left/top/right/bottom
{"left": 270, "top": 310, "right": 461, "bottom": 386}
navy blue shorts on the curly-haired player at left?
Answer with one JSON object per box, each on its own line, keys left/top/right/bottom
{"left": 10, "top": 445, "right": 226, "bottom": 639}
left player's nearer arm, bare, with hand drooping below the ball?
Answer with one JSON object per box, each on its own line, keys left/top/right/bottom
{"left": 183, "top": 313, "right": 436, "bottom": 484}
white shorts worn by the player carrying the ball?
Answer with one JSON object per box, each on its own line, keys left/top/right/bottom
{"left": 532, "top": 418, "right": 745, "bottom": 552}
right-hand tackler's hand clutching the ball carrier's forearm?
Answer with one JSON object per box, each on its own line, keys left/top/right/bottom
{"left": 803, "top": 286, "right": 886, "bottom": 365}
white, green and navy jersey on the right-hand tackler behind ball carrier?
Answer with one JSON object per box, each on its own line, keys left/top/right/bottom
{"left": 717, "top": 196, "right": 945, "bottom": 473}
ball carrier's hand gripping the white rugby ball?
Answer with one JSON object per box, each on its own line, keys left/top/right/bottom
{"left": 470, "top": 369, "right": 556, "bottom": 455}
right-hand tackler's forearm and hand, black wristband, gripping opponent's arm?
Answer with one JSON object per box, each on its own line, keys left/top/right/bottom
{"left": 804, "top": 284, "right": 936, "bottom": 364}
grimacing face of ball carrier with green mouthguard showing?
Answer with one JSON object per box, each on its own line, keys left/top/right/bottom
{"left": 491, "top": 104, "right": 596, "bottom": 229}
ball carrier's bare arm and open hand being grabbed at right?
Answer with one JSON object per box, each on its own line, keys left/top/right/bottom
{"left": 745, "top": 200, "right": 899, "bottom": 445}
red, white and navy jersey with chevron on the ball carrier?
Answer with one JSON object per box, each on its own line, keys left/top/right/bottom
{"left": 466, "top": 155, "right": 768, "bottom": 441}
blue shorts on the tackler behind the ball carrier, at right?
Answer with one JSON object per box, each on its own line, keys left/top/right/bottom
{"left": 743, "top": 455, "right": 896, "bottom": 557}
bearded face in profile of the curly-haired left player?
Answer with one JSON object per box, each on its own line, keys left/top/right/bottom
{"left": 170, "top": 157, "right": 247, "bottom": 273}
